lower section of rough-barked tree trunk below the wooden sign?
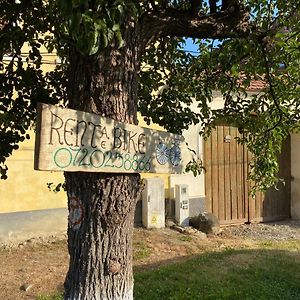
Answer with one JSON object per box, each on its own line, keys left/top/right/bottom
{"left": 65, "top": 173, "right": 140, "bottom": 300}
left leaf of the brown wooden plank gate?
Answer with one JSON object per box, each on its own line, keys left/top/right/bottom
{"left": 204, "top": 126, "right": 248, "bottom": 224}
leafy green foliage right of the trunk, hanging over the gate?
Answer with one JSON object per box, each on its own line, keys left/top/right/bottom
{"left": 140, "top": 1, "right": 300, "bottom": 191}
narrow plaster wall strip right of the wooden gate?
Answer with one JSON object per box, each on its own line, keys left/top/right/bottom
{"left": 291, "top": 134, "right": 300, "bottom": 219}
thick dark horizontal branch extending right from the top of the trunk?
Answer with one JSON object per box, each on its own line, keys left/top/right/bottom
{"left": 140, "top": 6, "right": 250, "bottom": 46}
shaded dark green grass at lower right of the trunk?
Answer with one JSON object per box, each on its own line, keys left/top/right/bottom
{"left": 134, "top": 249, "right": 300, "bottom": 300}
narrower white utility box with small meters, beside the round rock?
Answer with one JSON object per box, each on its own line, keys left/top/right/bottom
{"left": 175, "top": 184, "right": 190, "bottom": 227}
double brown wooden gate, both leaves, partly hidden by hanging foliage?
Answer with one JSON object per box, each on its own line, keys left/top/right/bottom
{"left": 204, "top": 126, "right": 291, "bottom": 225}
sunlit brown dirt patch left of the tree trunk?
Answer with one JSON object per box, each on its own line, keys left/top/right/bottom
{"left": 0, "top": 241, "right": 68, "bottom": 300}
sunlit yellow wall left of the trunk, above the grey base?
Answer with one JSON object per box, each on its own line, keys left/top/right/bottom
{"left": 0, "top": 132, "right": 67, "bottom": 213}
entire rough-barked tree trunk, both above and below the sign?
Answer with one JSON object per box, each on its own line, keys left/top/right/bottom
{"left": 64, "top": 22, "right": 141, "bottom": 300}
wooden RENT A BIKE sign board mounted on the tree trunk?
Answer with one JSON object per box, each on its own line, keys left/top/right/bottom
{"left": 34, "top": 104, "right": 189, "bottom": 173}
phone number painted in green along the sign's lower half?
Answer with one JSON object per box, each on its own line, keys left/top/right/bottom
{"left": 53, "top": 148, "right": 151, "bottom": 171}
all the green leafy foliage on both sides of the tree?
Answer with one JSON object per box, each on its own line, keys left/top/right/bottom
{"left": 0, "top": 0, "right": 300, "bottom": 189}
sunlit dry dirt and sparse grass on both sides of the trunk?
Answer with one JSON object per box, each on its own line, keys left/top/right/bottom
{"left": 0, "top": 223, "right": 300, "bottom": 300}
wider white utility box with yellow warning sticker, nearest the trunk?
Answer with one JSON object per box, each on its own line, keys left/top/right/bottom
{"left": 142, "top": 178, "right": 165, "bottom": 228}
